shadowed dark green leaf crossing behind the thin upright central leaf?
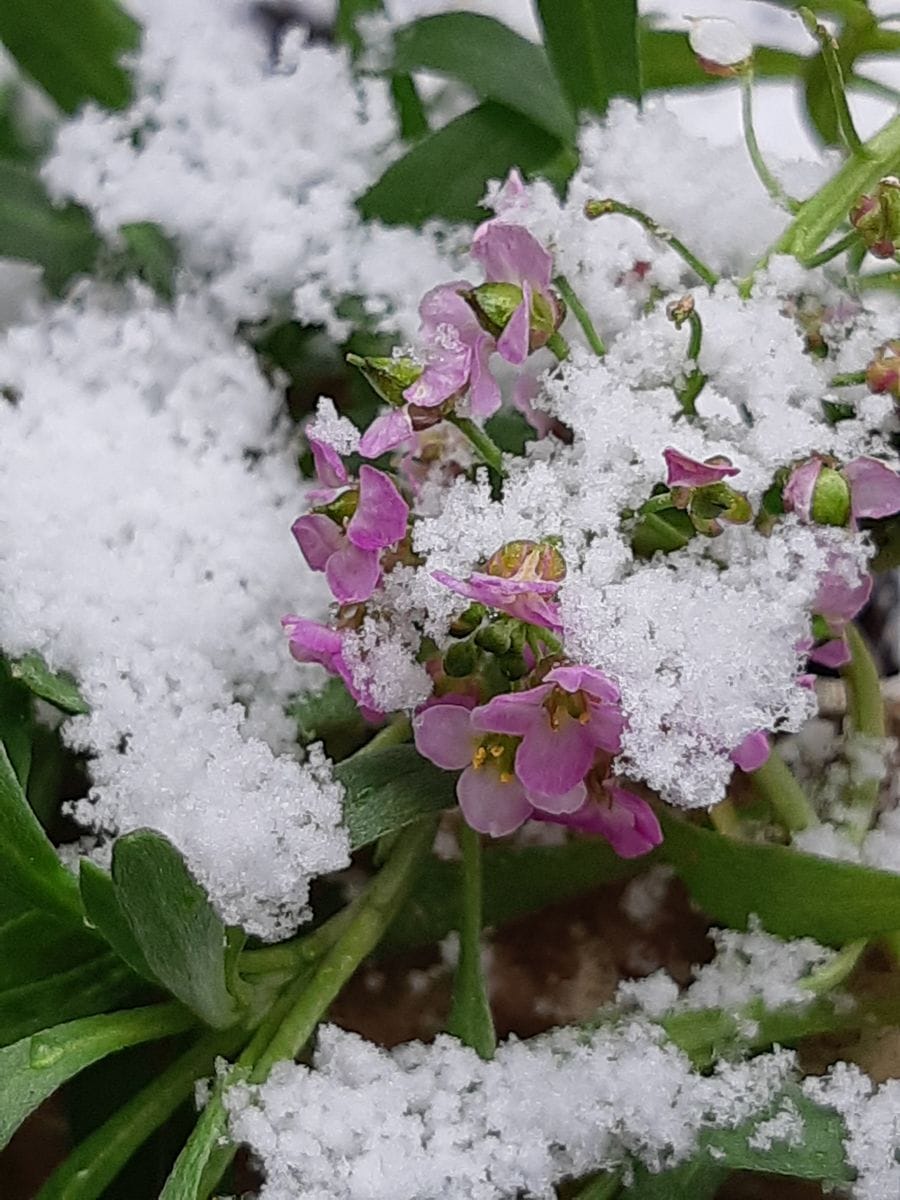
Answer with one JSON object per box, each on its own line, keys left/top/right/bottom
{"left": 382, "top": 840, "right": 643, "bottom": 950}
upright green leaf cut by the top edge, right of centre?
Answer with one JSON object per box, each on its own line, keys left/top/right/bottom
{"left": 538, "top": 0, "right": 642, "bottom": 113}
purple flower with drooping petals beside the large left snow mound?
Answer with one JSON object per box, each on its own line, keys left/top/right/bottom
{"left": 292, "top": 466, "right": 409, "bottom": 604}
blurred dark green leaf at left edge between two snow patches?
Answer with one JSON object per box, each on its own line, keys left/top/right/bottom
{"left": 0, "top": 159, "right": 100, "bottom": 293}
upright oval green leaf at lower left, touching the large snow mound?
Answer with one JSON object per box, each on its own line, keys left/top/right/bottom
{"left": 113, "top": 829, "right": 239, "bottom": 1028}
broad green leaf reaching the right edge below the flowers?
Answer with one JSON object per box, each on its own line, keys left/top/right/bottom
{"left": 658, "top": 810, "right": 900, "bottom": 946}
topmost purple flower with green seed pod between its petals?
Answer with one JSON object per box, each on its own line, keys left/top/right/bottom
{"left": 466, "top": 218, "right": 565, "bottom": 366}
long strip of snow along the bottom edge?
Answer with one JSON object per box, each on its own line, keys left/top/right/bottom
{"left": 227, "top": 1020, "right": 793, "bottom": 1200}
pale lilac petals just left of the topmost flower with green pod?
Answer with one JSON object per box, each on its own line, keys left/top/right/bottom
{"left": 403, "top": 280, "right": 500, "bottom": 418}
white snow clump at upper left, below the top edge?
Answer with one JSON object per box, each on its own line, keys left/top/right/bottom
{"left": 44, "top": 0, "right": 454, "bottom": 336}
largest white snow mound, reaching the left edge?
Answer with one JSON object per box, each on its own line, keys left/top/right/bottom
{"left": 0, "top": 290, "right": 347, "bottom": 936}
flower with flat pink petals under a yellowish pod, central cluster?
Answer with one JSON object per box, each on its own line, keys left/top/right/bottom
{"left": 432, "top": 541, "right": 565, "bottom": 630}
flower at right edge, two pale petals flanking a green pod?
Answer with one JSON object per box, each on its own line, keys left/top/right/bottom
{"left": 782, "top": 455, "right": 900, "bottom": 526}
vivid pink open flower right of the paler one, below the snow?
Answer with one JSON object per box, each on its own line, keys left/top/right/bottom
{"left": 472, "top": 666, "right": 625, "bottom": 811}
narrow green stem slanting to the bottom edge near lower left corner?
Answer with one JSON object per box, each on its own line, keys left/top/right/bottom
{"left": 37, "top": 1028, "right": 246, "bottom": 1200}
